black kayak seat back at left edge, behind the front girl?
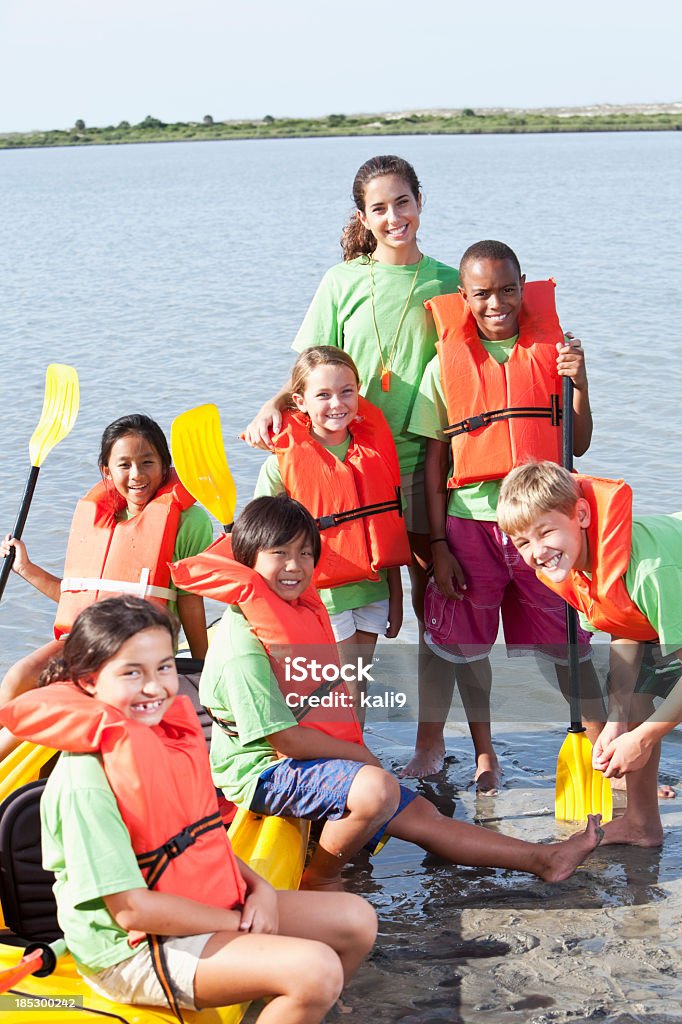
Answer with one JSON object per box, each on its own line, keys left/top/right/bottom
{"left": 0, "top": 779, "right": 62, "bottom": 942}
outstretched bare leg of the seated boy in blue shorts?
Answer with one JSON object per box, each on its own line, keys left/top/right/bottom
{"left": 386, "top": 797, "right": 603, "bottom": 882}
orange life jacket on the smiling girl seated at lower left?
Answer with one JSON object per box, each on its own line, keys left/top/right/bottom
{"left": 0, "top": 683, "right": 246, "bottom": 909}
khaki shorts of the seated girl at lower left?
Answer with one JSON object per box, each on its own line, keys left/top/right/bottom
{"left": 85, "top": 933, "right": 213, "bottom": 1010}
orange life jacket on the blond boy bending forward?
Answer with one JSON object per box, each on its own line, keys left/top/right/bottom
{"left": 538, "top": 474, "right": 656, "bottom": 640}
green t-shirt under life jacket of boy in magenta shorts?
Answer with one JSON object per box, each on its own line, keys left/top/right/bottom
{"left": 410, "top": 335, "right": 518, "bottom": 522}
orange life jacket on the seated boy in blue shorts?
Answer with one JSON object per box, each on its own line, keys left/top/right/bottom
{"left": 171, "top": 536, "right": 363, "bottom": 743}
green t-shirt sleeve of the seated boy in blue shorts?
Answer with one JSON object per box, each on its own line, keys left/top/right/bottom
{"left": 199, "top": 607, "right": 297, "bottom": 745}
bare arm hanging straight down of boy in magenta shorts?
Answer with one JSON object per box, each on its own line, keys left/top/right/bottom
{"left": 424, "top": 437, "right": 466, "bottom": 601}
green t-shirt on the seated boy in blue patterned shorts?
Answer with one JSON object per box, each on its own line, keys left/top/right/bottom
{"left": 199, "top": 605, "right": 297, "bottom": 807}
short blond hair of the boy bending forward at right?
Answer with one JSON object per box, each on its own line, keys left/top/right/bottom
{"left": 498, "top": 462, "right": 581, "bottom": 537}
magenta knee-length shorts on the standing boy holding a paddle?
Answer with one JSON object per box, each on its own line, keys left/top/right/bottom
{"left": 424, "top": 515, "right": 591, "bottom": 665}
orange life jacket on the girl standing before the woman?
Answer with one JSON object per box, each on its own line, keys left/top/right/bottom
{"left": 272, "top": 397, "right": 412, "bottom": 587}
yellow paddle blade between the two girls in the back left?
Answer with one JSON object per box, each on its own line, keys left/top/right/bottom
{"left": 171, "top": 404, "right": 237, "bottom": 526}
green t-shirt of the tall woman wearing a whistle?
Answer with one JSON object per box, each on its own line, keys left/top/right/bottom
{"left": 293, "top": 256, "right": 460, "bottom": 474}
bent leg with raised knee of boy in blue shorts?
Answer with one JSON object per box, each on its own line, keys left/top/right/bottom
{"left": 301, "top": 765, "right": 400, "bottom": 891}
